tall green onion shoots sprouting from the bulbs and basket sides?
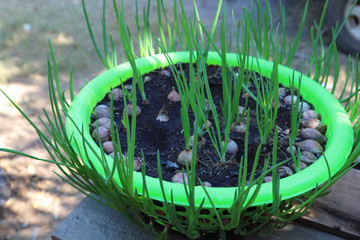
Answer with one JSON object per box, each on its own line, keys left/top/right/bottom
{"left": 0, "top": 0, "right": 360, "bottom": 239}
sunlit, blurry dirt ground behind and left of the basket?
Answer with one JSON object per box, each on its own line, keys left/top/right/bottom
{"left": 0, "top": 0, "right": 354, "bottom": 240}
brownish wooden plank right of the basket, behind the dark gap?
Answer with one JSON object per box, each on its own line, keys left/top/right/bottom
{"left": 297, "top": 169, "right": 360, "bottom": 239}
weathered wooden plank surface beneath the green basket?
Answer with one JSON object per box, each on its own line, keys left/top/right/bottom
{"left": 52, "top": 169, "right": 360, "bottom": 240}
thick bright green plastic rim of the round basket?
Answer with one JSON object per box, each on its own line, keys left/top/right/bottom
{"left": 66, "top": 52, "right": 353, "bottom": 208}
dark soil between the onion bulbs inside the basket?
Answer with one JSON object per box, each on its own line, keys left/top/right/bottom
{"left": 90, "top": 64, "right": 320, "bottom": 187}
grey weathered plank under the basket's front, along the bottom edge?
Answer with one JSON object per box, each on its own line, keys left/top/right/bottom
{"left": 52, "top": 197, "right": 341, "bottom": 240}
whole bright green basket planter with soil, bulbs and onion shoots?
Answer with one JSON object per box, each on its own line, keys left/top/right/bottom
{"left": 0, "top": 0, "right": 360, "bottom": 239}
